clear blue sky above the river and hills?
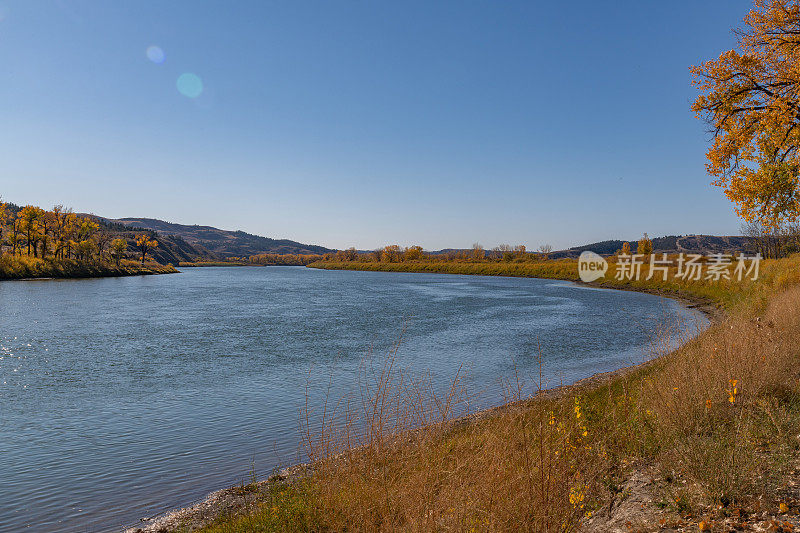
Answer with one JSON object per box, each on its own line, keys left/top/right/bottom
{"left": 0, "top": 0, "right": 750, "bottom": 249}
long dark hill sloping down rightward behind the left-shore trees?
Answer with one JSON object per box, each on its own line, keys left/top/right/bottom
{"left": 109, "top": 218, "right": 336, "bottom": 259}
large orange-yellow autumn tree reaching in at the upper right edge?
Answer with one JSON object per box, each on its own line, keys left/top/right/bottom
{"left": 691, "top": 0, "right": 800, "bottom": 229}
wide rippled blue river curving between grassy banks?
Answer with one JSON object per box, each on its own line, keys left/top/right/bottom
{"left": 0, "top": 267, "right": 707, "bottom": 532}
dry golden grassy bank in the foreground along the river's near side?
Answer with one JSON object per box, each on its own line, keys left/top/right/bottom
{"left": 162, "top": 257, "right": 800, "bottom": 533}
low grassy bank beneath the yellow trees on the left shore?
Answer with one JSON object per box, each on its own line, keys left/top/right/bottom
{"left": 0, "top": 255, "right": 177, "bottom": 280}
